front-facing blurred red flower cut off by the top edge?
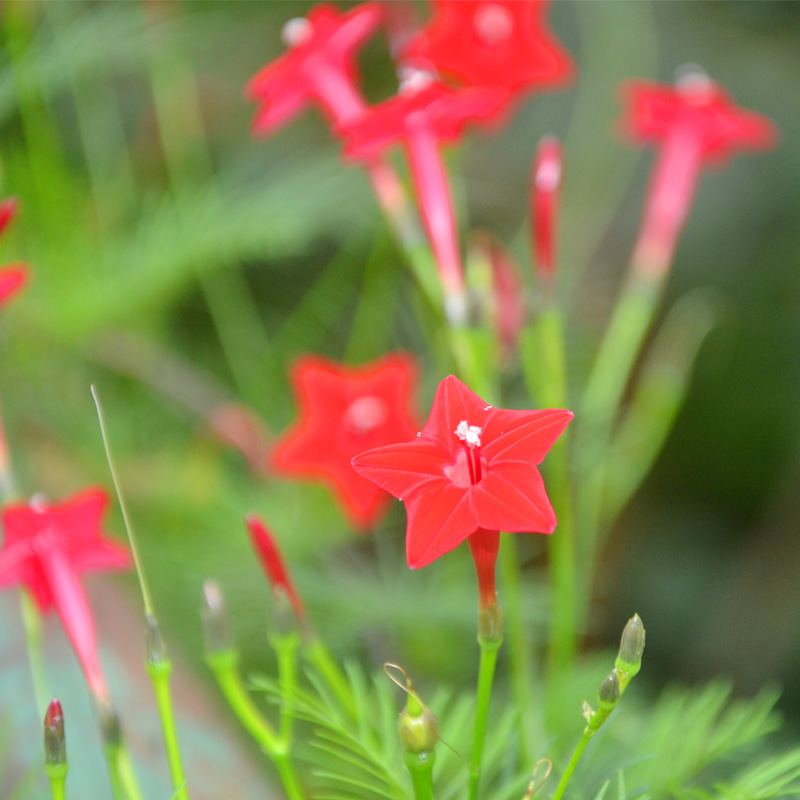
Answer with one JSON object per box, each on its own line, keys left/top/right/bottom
{"left": 405, "top": 0, "right": 572, "bottom": 101}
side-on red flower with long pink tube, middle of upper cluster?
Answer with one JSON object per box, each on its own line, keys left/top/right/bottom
{"left": 345, "top": 77, "right": 503, "bottom": 321}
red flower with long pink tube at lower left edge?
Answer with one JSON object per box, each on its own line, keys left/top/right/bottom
{"left": 0, "top": 489, "right": 131, "bottom": 699}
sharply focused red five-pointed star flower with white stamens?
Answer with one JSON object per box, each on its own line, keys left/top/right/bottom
{"left": 353, "top": 375, "right": 573, "bottom": 569}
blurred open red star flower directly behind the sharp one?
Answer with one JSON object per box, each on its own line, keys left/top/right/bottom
{"left": 273, "top": 353, "right": 418, "bottom": 529}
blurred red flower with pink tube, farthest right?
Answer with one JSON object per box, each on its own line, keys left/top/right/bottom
{"left": 622, "top": 69, "right": 777, "bottom": 273}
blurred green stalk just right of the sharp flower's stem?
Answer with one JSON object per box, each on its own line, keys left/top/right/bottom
{"left": 500, "top": 534, "right": 536, "bottom": 764}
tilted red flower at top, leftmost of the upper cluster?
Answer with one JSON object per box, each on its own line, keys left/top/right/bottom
{"left": 246, "top": 3, "right": 381, "bottom": 134}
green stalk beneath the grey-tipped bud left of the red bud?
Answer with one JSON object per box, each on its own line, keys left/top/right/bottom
{"left": 206, "top": 650, "right": 305, "bottom": 800}
